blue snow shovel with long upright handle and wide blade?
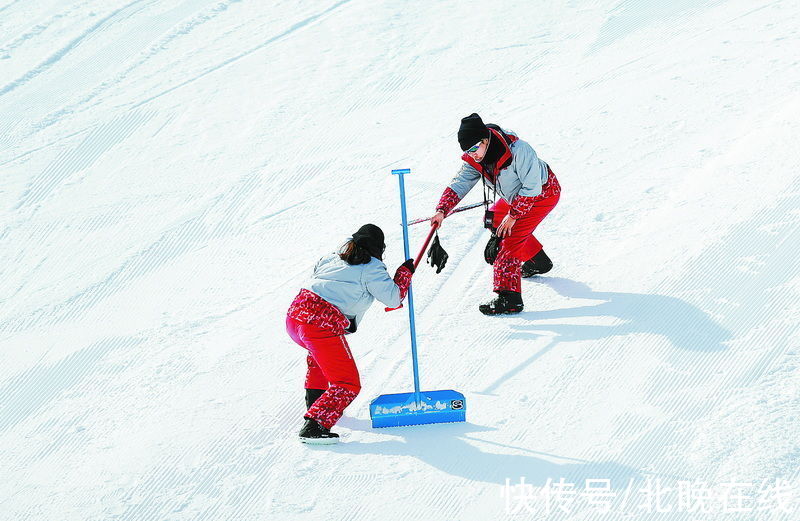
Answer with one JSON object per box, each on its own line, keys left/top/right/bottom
{"left": 369, "top": 168, "right": 467, "bottom": 427}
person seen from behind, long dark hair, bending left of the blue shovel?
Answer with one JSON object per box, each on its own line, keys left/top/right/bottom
{"left": 286, "top": 224, "right": 414, "bottom": 444}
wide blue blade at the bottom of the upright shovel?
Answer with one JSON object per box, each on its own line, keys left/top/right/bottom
{"left": 369, "top": 389, "right": 467, "bottom": 428}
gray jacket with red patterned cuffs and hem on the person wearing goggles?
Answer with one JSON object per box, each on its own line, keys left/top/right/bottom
{"left": 436, "top": 125, "right": 549, "bottom": 218}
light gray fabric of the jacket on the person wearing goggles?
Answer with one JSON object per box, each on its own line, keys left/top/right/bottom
{"left": 450, "top": 130, "right": 548, "bottom": 204}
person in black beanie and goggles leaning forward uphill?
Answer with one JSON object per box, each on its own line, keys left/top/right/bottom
{"left": 431, "top": 113, "right": 561, "bottom": 315}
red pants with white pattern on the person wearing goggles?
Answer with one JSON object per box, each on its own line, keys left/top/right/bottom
{"left": 490, "top": 168, "right": 561, "bottom": 293}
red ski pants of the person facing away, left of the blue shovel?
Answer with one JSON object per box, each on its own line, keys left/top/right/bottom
{"left": 286, "top": 317, "right": 361, "bottom": 429}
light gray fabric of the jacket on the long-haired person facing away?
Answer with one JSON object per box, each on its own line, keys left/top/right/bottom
{"left": 303, "top": 253, "right": 400, "bottom": 326}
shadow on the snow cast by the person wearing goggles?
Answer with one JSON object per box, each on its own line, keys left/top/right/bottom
{"left": 482, "top": 277, "right": 732, "bottom": 393}
